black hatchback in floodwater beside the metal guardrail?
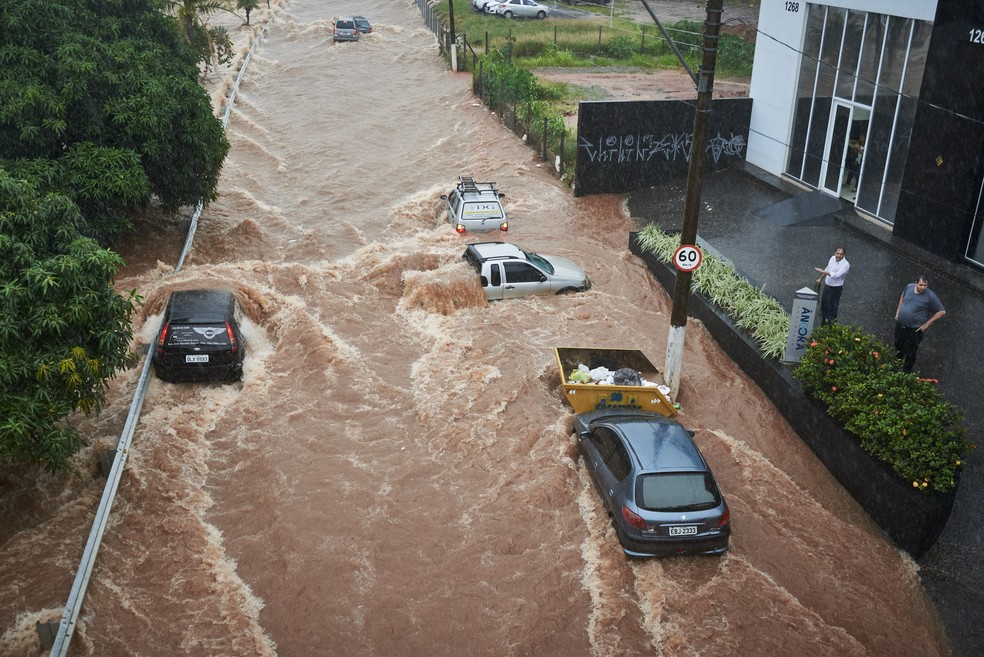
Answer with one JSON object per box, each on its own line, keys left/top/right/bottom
{"left": 154, "top": 290, "right": 245, "bottom": 382}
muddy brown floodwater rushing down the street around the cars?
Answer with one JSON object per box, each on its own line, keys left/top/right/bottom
{"left": 0, "top": 0, "right": 949, "bottom": 657}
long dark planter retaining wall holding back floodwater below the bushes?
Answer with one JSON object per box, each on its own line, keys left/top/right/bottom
{"left": 629, "top": 233, "right": 956, "bottom": 559}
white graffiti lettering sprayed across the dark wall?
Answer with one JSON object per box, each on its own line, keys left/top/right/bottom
{"left": 578, "top": 132, "right": 747, "bottom": 164}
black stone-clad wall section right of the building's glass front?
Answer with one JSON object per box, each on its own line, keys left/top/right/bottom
{"left": 894, "top": 0, "right": 984, "bottom": 261}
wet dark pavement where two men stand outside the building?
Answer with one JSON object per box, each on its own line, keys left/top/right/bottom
{"left": 629, "top": 165, "right": 984, "bottom": 657}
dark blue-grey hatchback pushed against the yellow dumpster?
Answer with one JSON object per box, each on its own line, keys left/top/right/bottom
{"left": 575, "top": 410, "right": 731, "bottom": 557}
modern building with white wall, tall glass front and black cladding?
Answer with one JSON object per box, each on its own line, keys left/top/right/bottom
{"left": 746, "top": 0, "right": 984, "bottom": 266}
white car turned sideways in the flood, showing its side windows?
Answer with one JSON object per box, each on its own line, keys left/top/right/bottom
{"left": 462, "top": 242, "right": 591, "bottom": 301}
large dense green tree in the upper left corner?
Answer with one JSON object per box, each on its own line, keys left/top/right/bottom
{"left": 0, "top": 0, "right": 229, "bottom": 243}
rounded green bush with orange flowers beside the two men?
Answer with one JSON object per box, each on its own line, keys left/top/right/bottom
{"left": 793, "top": 324, "right": 971, "bottom": 492}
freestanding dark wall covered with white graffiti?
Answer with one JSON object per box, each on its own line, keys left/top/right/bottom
{"left": 574, "top": 97, "right": 752, "bottom": 196}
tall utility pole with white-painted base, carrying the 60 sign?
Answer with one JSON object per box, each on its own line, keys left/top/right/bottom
{"left": 660, "top": 0, "right": 724, "bottom": 397}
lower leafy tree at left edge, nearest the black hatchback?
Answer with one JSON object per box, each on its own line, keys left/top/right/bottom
{"left": 0, "top": 169, "right": 139, "bottom": 470}
